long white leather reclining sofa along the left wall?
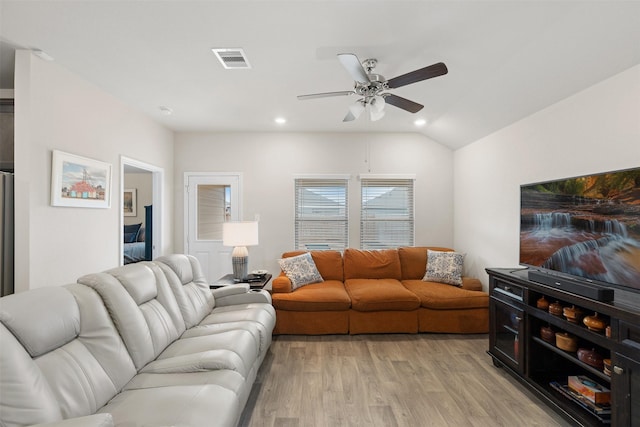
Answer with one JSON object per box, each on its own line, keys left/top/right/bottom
{"left": 0, "top": 255, "right": 275, "bottom": 427}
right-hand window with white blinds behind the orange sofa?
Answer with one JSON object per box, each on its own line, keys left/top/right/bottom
{"left": 360, "top": 177, "right": 414, "bottom": 249}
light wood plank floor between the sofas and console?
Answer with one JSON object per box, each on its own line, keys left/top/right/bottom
{"left": 240, "top": 334, "right": 569, "bottom": 427}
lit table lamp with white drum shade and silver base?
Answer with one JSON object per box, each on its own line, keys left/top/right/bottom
{"left": 222, "top": 221, "right": 258, "bottom": 282}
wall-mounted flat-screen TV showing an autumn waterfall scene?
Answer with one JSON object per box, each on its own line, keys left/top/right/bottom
{"left": 520, "top": 168, "right": 640, "bottom": 291}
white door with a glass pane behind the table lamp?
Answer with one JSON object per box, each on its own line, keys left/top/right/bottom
{"left": 185, "top": 173, "right": 242, "bottom": 283}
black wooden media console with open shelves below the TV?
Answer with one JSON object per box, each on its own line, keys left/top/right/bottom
{"left": 487, "top": 269, "right": 640, "bottom": 427}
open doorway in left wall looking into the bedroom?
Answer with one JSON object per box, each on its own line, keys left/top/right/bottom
{"left": 120, "top": 156, "right": 164, "bottom": 265}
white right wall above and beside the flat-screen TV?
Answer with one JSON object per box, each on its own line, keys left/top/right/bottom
{"left": 454, "top": 65, "right": 640, "bottom": 286}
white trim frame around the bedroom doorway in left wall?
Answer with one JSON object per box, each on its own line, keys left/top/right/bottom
{"left": 118, "top": 156, "right": 164, "bottom": 265}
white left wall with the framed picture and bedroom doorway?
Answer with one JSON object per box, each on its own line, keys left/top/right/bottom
{"left": 15, "top": 51, "right": 173, "bottom": 291}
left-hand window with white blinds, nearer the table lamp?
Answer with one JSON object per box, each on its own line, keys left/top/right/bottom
{"left": 295, "top": 178, "right": 349, "bottom": 251}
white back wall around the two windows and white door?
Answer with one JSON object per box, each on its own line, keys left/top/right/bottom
{"left": 174, "top": 133, "right": 453, "bottom": 279}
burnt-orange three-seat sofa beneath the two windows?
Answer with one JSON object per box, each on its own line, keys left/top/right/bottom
{"left": 272, "top": 247, "right": 489, "bottom": 335}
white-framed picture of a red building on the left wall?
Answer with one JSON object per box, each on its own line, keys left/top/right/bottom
{"left": 51, "top": 150, "right": 111, "bottom": 208}
